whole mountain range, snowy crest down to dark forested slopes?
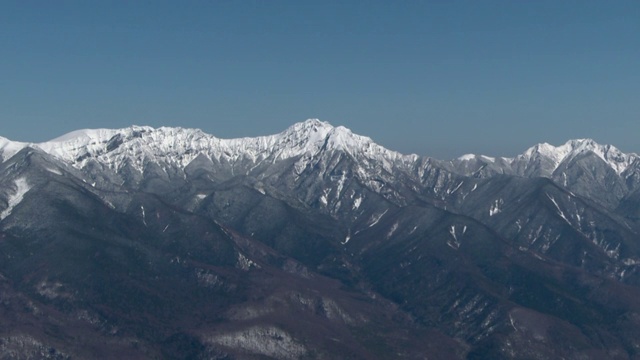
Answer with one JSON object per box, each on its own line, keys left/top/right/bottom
{"left": 0, "top": 119, "right": 640, "bottom": 359}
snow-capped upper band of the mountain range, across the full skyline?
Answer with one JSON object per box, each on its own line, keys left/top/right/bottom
{"left": 0, "top": 119, "right": 640, "bottom": 210}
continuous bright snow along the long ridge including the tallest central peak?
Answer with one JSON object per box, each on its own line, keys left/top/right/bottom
{"left": 21, "top": 119, "right": 418, "bottom": 171}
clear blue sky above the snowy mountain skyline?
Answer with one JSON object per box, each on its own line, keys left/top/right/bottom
{"left": 0, "top": 0, "right": 640, "bottom": 158}
